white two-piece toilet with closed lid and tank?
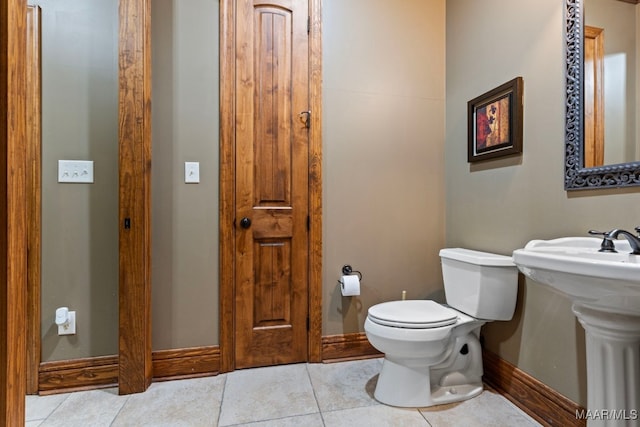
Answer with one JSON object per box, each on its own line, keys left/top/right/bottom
{"left": 364, "top": 248, "right": 518, "bottom": 407}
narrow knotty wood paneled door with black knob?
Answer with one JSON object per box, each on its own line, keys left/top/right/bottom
{"left": 234, "top": 0, "right": 310, "bottom": 368}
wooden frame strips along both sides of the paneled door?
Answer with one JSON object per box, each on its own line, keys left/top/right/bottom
{"left": 219, "top": 0, "right": 322, "bottom": 372}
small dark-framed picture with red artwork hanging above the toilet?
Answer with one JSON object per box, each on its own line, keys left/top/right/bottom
{"left": 467, "top": 77, "right": 524, "bottom": 162}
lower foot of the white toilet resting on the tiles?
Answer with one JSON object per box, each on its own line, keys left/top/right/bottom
{"left": 374, "top": 358, "right": 483, "bottom": 408}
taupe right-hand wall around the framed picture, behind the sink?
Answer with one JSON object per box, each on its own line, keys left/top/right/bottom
{"left": 445, "top": 0, "right": 640, "bottom": 405}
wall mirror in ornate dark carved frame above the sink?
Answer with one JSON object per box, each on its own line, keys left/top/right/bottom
{"left": 565, "top": 0, "right": 640, "bottom": 190}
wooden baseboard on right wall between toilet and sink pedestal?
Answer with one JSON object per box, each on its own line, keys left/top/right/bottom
{"left": 482, "top": 350, "right": 586, "bottom": 427}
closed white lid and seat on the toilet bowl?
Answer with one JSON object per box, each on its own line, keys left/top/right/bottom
{"left": 369, "top": 300, "right": 458, "bottom": 329}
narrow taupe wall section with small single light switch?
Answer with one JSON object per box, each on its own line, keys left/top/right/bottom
{"left": 151, "top": 0, "right": 220, "bottom": 350}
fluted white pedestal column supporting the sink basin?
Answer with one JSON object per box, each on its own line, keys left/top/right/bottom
{"left": 573, "top": 302, "right": 640, "bottom": 427}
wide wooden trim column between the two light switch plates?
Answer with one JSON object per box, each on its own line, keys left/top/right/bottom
{"left": 118, "top": 0, "right": 153, "bottom": 394}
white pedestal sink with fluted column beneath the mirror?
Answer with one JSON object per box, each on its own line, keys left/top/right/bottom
{"left": 513, "top": 237, "right": 640, "bottom": 427}
